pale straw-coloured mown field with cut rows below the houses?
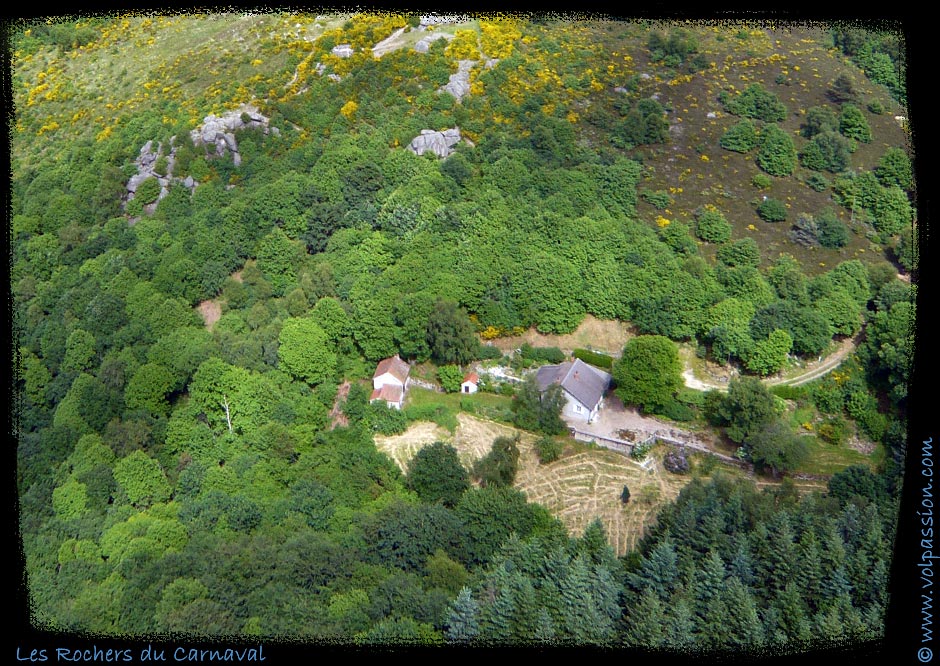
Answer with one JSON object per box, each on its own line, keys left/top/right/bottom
{"left": 375, "top": 414, "right": 692, "bottom": 555}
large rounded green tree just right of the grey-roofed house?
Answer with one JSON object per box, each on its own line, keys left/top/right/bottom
{"left": 613, "top": 335, "right": 682, "bottom": 412}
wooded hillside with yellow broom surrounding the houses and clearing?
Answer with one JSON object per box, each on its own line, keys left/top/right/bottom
{"left": 9, "top": 13, "right": 917, "bottom": 652}
